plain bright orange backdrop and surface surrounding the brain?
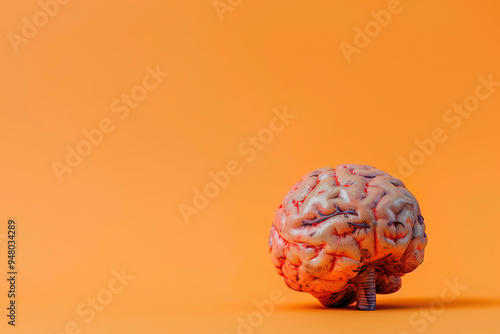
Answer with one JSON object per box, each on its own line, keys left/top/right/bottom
{"left": 0, "top": 0, "right": 500, "bottom": 334}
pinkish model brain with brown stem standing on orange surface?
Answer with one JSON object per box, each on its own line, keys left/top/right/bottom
{"left": 269, "top": 164, "right": 427, "bottom": 310}
